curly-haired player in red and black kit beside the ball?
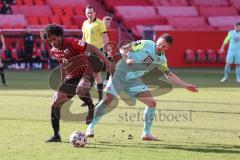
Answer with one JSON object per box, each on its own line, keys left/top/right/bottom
{"left": 40, "top": 24, "right": 111, "bottom": 142}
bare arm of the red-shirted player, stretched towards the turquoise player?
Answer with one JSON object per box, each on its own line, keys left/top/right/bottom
{"left": 86, "top": 44, "right": 114, "bottom": 74}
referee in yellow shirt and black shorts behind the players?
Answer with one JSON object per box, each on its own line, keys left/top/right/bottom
{"left": 82, "top": 6, "right": 109, "bottom": 105}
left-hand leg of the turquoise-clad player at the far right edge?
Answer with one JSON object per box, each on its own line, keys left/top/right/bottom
{"left": 220, "top": 51, "right": 234, "bottom": 83}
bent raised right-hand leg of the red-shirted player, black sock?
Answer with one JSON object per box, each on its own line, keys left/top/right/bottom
{"left": 76, "top": 77, "right": 94, "bottom": 124}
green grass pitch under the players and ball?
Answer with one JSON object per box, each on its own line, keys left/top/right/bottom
{"left": 0, "top": 69, "right": 240, "bottom": 160}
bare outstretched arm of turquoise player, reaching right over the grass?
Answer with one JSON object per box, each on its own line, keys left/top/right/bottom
{"left": 166, "top": 72, "right": 198, "bottom": 92}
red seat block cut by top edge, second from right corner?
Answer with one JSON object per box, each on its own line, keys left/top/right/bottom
{"left": 191, "top": 0, "right": 229, "bottom": 6}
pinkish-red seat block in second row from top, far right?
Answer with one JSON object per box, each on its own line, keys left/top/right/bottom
{"left": 199, "top": 7, "right": 238, "bottom": 17}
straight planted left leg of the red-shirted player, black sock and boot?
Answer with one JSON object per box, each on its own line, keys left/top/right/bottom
{"left": 46, "top": 91, "right": 69, "bottom": 142}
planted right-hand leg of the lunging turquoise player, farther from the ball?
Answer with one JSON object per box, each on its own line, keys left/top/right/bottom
{"left": 137, "top": 91, "right": 157, "bottom": 140}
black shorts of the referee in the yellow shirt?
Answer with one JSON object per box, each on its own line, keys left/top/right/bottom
{"left": 88, "top": 49, "right": 106, "bottom": 73}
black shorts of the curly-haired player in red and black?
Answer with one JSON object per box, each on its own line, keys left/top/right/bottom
{"left": 58, "top": 76, "right": 94, "bottom": 99}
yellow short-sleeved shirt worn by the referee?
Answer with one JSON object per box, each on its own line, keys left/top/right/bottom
{"left": 82, "top": 18, "right": 107, "bottom": 49}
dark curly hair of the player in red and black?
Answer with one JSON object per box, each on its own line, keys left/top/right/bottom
{"left": 40, "top": 24, "right": 64, "bottom": 40}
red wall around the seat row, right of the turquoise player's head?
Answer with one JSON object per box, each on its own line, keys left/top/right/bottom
{"left": 157, "top": 31, "right": 227, "bottom": 67}
